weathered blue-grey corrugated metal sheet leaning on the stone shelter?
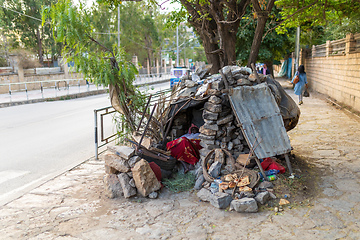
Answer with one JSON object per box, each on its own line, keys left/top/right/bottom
{"left": 230, "top": 83, "right": 291, "bottom": 159}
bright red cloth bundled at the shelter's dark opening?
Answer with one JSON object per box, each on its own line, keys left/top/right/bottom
{"left": 166, "top": 137, "right": 202, "bottom": 165}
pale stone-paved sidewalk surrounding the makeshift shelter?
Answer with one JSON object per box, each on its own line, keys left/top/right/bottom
{"left": 0, "top": 79, "right": 360, "bottom": 240}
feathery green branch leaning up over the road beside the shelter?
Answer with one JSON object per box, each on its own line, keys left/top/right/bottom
{"left": 42, "top": 0, "right": 145, "bottom": 133}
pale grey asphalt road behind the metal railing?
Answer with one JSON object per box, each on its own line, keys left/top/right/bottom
{"left": 0, "top": 83, "right": 169, "bottom": 206}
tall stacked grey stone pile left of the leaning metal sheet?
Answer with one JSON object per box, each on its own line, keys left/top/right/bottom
{"left": 179, "top": 66, "right": 276, "bottom": 212}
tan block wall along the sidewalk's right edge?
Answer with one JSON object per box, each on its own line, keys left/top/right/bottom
{"left": 302, "top": 34, "right": 360, "bottom": 111}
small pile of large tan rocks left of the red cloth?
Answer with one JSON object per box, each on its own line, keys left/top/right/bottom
{"left": 103, "top": 146, "right": 161, "bottom": 198}
